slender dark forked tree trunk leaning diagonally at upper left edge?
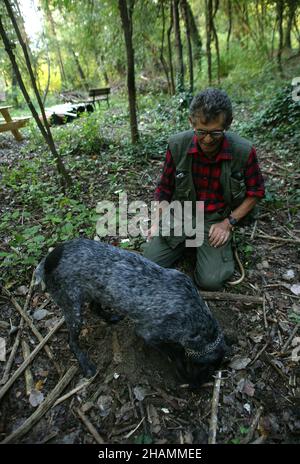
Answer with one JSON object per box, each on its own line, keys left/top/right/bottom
{"left": 0, "top": 0, "right": 71, "bottom": 186}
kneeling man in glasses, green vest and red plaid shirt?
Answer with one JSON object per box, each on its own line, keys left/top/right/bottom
{"left": 144, "top": 88, "right": 265, "bottom": 290}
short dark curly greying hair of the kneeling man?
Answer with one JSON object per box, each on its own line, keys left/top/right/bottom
{"left": 190, "top": 88, "right": 232, "bottom": 128}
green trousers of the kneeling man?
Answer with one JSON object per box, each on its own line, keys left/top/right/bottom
{"left": 144, "top": 214, "right": 234, "bottom": 291}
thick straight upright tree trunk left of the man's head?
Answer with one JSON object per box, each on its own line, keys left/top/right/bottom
{"left": 119, "top": 0, "right": 139, "bottom": 143}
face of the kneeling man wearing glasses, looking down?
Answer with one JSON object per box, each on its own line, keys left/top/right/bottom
{"left": 190, "top": 114, "right": 225, "bottom": 156}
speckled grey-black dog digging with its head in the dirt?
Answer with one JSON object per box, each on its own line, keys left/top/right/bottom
{"left": 35, "top": 239, "right": 228, "bottom": 386}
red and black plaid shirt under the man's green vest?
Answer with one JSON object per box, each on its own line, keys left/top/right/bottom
{"left": 155, "top": 135, "right": 265, "bottom": 213}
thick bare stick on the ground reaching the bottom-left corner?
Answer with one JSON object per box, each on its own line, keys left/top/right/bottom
{"left": 1, "top": 364, "right": 78, "bottom": 444}
